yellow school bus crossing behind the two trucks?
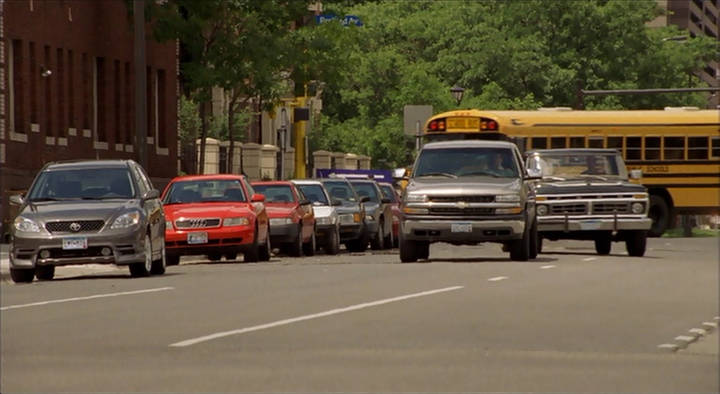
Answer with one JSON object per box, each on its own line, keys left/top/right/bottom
{"left": 423, "top": 107, "right": 720, "bottom": 236}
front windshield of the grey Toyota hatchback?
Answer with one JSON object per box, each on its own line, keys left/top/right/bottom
{"left": 28, "top": 168, "right": 136, "bottom": 201}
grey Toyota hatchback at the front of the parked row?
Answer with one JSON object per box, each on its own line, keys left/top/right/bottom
{"left": 10, "top": 160, "right": 165, "bottom": 282}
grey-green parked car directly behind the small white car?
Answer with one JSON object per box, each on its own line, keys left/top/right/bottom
{"left": 320, "top": 178, "right": 369, "bottom": 252}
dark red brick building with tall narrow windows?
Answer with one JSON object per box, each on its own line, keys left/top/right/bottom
{"left": 0, "top": 0, "right": 178, "bottom": 235}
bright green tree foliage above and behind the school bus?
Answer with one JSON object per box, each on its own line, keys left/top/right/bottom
{"left": 311, "top": 0, "right": 719, "bottom": 167}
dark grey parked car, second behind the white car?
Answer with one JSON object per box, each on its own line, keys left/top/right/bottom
{"left": 349, "top": 179, "right": 394, "bottom": 250}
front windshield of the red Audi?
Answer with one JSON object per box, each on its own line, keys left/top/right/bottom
{"left": 163, "top": 179, "right": 247, "bottom": 204}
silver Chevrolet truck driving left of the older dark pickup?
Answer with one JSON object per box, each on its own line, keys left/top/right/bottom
{"left": 399, "top": 140, "right": 537, "bottom": 262}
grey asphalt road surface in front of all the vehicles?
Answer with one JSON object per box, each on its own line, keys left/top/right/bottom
{"left": 0, "top": 238, "right": 720, "bottom": 393}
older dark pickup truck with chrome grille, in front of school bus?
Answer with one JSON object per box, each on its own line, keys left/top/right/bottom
{"left": 526, "top": 149, "right": 652, "bottom": 256}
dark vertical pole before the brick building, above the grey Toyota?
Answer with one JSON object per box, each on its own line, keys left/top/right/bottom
{"left": 133, "top": 0, "right": 149, "bottom": 168}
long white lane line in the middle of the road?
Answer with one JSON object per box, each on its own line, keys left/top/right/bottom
{"left": 170, "top": 286, "right": 464, "bottom": 347}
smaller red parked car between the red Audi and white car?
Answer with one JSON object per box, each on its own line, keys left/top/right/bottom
{"left": 252, "top": 181, "right": 317, "bottom": 257}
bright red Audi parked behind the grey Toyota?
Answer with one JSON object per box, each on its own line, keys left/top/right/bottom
{"left": 162, "top": 175, "right": 271, "bottom": 265}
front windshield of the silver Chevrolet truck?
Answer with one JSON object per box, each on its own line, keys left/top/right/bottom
{"left": 413, "top": 148, "right": 519, "bottom": 178}
